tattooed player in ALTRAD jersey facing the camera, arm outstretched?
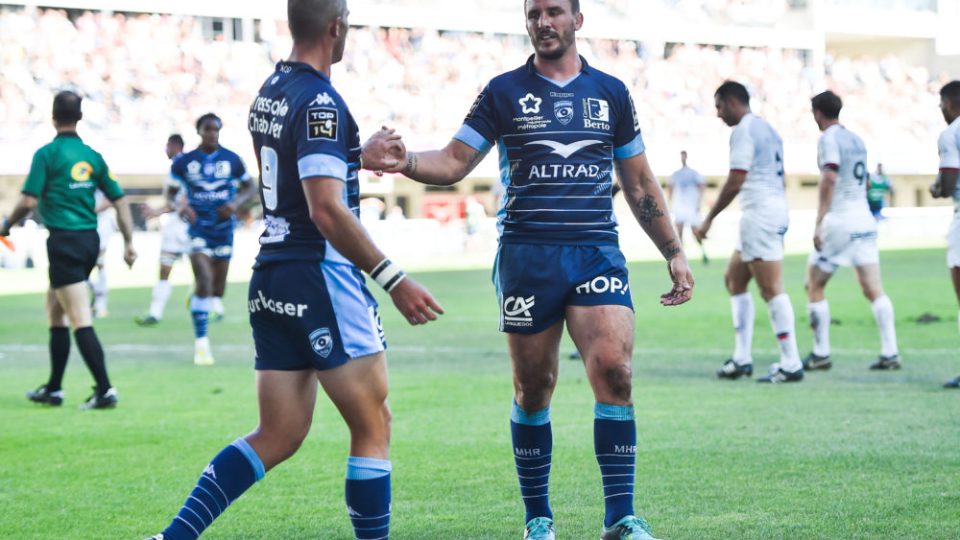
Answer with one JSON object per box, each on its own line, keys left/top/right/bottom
{"left": 386, "top": 0, "right": 693, "bottom": 540}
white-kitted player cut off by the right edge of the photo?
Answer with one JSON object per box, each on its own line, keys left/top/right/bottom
{"left": 930, "top": 80, "right": 960, "bottom": 388}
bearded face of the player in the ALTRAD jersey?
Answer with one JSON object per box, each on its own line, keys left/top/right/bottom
{"left": 524, "top": 0, "right": 583, "bottom": 60}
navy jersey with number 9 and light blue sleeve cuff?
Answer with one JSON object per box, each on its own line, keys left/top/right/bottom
{"left": 248, "top": 62, "right": 360, "bottom": 264}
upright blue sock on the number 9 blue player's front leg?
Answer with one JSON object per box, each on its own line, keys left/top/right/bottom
{"left": 345, "top": 456, "right": 391, "bottom": 540}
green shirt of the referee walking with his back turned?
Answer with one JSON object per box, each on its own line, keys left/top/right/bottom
{"left": 22, "top": 132, "right": 123, "bottom": 231}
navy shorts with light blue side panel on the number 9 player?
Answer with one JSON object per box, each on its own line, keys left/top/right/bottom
{"left": 247, "top": 261, "right": 387, "bottom": 371}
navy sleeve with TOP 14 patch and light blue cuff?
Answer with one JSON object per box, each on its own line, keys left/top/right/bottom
{"left": 293, "top": 87, "right": 350, "bottom": 182}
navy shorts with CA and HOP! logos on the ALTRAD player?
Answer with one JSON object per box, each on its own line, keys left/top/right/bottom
{"left": 493, "top": 244, "right": 633, "bottom": 334}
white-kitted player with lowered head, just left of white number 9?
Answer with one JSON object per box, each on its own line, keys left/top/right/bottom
{"left": 695, "top": 81, "right": 803, "bottom": 383}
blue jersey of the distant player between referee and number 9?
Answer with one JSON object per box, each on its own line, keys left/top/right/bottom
{"left": 170, "top": 146, "right": 250, "bottom": 234}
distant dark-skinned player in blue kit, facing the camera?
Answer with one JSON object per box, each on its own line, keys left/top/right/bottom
{"left": 168, "top": 113, "right": 256, "bottom": 366}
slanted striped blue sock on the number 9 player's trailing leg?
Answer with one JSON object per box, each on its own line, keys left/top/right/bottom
{"left": 163, "top": 439, "right": 264, "bottom": 540}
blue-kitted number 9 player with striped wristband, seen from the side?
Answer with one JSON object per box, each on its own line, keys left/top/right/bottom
{"left": 145, "top": 0, "right": 443, "bottom": 540}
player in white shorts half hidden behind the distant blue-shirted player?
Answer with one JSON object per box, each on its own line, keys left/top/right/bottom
{"left": 134, "top": 133, "right": 190, "bottom": 326}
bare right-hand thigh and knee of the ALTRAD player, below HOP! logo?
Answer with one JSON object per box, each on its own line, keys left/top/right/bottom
{"left": 567, "top": 305, "right": 634, "bottom": 404}
